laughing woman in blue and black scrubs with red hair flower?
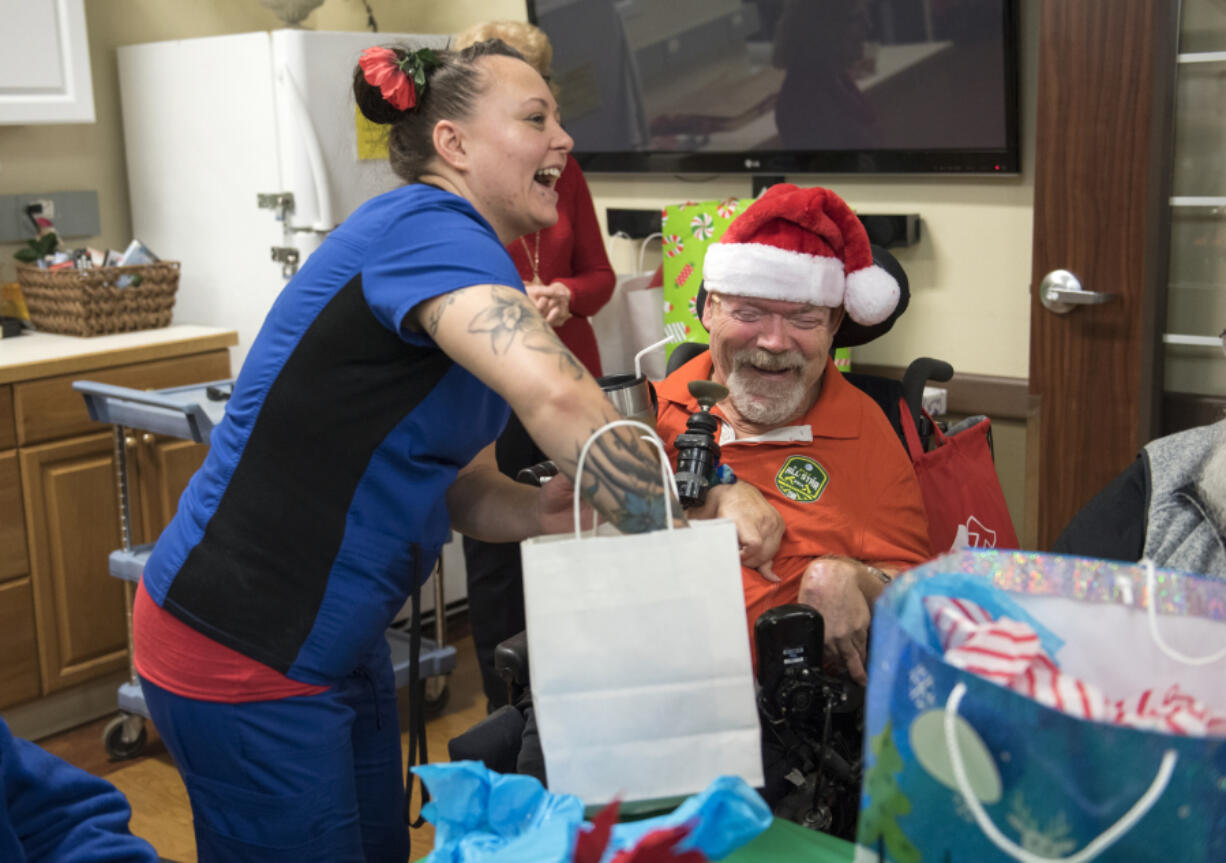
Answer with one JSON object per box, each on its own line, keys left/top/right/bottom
{"left": 135, "top": 40, "right": 691, "bottom": 863}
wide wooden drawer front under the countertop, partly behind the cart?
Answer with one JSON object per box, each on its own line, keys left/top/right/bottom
{"left": 12, "top": 349, "right": 230, "bottom": 446}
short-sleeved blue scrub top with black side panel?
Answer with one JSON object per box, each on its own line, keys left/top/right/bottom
{"left": 145, "top": 184, "right": 524, "bottom": 684}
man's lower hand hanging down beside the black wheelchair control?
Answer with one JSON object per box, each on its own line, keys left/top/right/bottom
{"left": 799, "top": 558, "right": 874, "bottom": 685}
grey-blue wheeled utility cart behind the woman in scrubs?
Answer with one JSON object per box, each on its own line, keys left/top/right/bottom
{"left": 72, "top": 380, "right": 456, "bottom": 759}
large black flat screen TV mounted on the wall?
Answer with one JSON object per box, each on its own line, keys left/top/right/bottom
{"left": 527, "top": 0, "right": 1020, "bottom": 175}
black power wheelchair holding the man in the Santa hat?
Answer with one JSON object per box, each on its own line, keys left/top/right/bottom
{"left": 449, "top": 246, "right": 970, "bottom": 838}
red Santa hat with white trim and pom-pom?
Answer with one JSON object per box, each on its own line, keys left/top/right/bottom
{"left": 702, "top": 183, "right": 900, "bottom": 325}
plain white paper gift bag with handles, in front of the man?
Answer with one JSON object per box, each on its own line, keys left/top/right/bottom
{"left": 521, "top": 420, "right": 763, "bottom": 805}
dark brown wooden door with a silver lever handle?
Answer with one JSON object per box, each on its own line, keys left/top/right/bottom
{"left": 1024, "top": 0, "right": 1179, "bottom": 549}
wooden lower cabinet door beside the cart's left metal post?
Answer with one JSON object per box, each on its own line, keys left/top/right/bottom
{"left": 20, "top": 432, "right": 130, "bottom": 695}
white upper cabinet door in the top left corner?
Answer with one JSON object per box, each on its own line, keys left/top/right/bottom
{"left": 0, "top": 0, "right": 93, "bottom": 124}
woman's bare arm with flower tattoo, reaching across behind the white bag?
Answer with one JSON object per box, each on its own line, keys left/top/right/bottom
{"left": 414, "top": 284, "right": 684, "bottom": 533}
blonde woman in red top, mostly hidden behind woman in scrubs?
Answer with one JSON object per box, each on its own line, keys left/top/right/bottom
{"left": 451, "top": 21, "right": 617, "bottom": 710}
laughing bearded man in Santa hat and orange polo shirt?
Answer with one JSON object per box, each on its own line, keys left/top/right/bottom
{"left": 657, "top": 184, "right": 929, "bottom": 684}
